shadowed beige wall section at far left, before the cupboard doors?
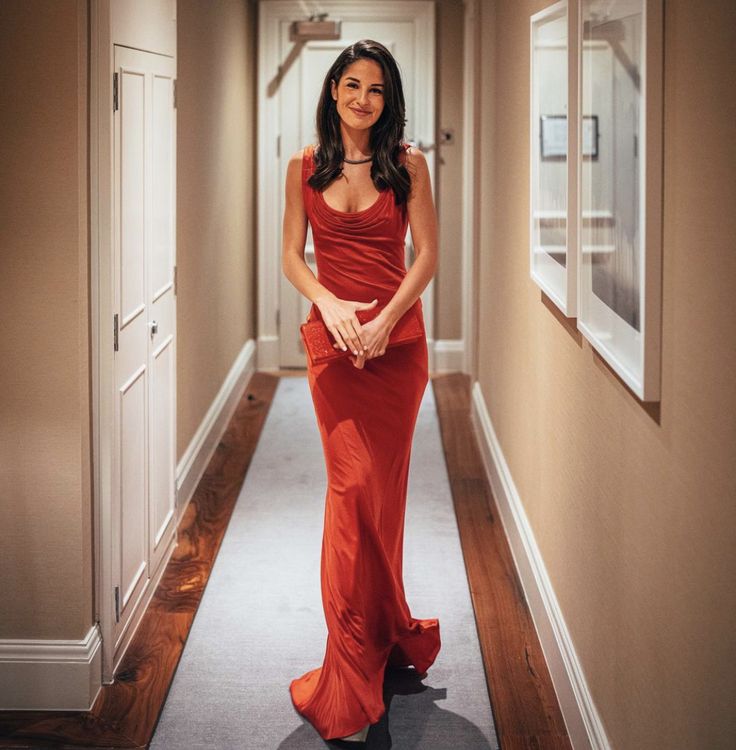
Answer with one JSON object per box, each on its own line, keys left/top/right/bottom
{"left": 0, "top": 0, "right": 93, "bottom": 638}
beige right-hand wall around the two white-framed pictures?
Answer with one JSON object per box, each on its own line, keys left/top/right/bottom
{"left": 479, "top": 0, "right": 736, "bottom": 750}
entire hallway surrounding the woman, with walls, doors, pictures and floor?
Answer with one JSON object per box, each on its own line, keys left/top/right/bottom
{"left": 0, "top": 0, "right": 736, "bottom": 750}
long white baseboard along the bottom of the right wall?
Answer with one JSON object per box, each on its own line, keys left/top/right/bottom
{"left": 471, "top": 381, "right": 611, "bottom": 750}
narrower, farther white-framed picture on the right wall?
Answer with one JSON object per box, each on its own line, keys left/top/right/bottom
{"left": 529, "top": 0, "right": 578, "bottom": 317}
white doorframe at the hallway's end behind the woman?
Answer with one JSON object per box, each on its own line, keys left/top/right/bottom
{"left": 257, "top": 0, "right": 437, "bottom": 371}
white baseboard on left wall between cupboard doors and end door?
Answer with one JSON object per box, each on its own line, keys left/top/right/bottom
{"left": 176, "top": 339, "right": 256, "bottom": 523}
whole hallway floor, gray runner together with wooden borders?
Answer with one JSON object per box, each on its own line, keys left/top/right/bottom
{"left": 0, "top": 371, "right": 570, "bottom": 750}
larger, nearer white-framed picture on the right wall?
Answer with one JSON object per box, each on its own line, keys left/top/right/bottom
{"left": 577, "top": 0, "right": 663, "bottom": 401}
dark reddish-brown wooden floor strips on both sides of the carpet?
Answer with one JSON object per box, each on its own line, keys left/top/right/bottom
{"left": 0, "top": 371, "right": 570, "bottom": 750}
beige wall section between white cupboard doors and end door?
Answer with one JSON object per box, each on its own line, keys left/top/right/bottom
{"left": 176, "top": 0, "right": 256, "bottom": 459}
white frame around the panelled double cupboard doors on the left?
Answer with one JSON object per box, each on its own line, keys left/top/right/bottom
{"left": 89, "top": 0, "right": 180, "bottom": 684}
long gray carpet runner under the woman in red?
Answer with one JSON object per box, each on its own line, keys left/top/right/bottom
{"left": 150, "top": 377, "right": 499, "bottom": 750}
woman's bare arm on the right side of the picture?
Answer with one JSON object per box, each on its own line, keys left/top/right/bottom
{"left": 376, "top": 147, "right": 437, "bottom": 327}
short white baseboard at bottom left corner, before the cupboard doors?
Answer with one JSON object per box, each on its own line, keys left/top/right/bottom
{"left": 0, "top": 623, "right": 102, "bottom": 711}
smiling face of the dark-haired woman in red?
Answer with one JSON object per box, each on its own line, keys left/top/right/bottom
{"left": 332, "top": 57, "right": 384, "bottom": 136}
